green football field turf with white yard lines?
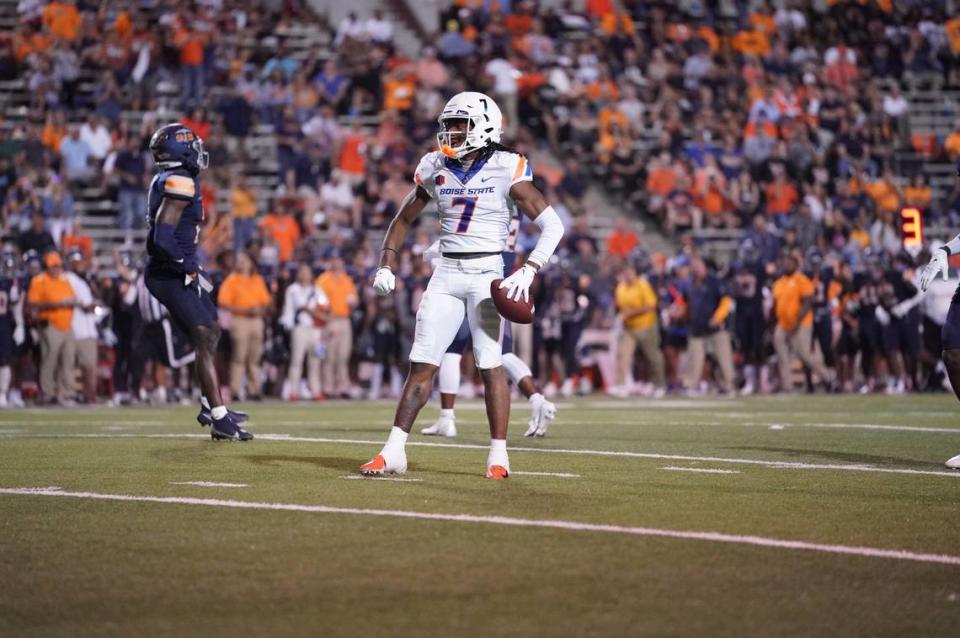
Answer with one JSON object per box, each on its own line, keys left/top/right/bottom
{"left": 0, "top": 395, "right": 960, "bottom": 636}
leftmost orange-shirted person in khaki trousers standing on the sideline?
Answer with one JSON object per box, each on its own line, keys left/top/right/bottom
{"left": 27, "top": 252, "right": 76, "bottom": 403}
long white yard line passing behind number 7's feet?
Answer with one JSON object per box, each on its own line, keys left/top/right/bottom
{"left": 0, "top": 433, "right": 960, "bottom": 478}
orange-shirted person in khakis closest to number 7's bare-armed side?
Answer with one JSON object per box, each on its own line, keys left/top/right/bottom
{"left": 316, "top": 257, "right": 359, "bottom": 398}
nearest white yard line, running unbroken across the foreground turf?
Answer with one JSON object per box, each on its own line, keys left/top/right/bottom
{"left": 0, "top": 487, "right": 960, "bottom": 566}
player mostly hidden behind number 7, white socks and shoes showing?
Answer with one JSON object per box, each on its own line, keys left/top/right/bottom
{"left": 420, "top": 240, "right": 557, "bottom": 437}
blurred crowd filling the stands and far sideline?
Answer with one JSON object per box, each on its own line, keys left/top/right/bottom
{"left": 0, "top": 0, "right": 960, "bottom": 401}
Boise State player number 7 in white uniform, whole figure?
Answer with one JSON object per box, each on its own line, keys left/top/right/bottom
{"left": 360, "top": 92, "right": 563, "bottom": 480}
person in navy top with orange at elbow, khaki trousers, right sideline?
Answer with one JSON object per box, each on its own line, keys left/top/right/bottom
{"left": 684, "top": 257, "right": 733, "bottom": 393}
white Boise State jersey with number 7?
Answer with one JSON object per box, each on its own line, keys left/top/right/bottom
{"left": 414, "top": 151, "right": 533, "bottom": 253}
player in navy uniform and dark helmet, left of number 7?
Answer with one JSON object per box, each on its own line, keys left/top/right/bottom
{"left": 144, "top": 124, "right": 253, "bottom": 441}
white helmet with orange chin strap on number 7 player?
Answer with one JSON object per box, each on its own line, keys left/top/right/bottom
{"left": 437, "top": 91, "right": 503, "bottom": 159}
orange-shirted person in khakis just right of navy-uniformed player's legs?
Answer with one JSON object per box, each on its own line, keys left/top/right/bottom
{"left": 217, "top": 252, "right": 270, "bottom": 399}
